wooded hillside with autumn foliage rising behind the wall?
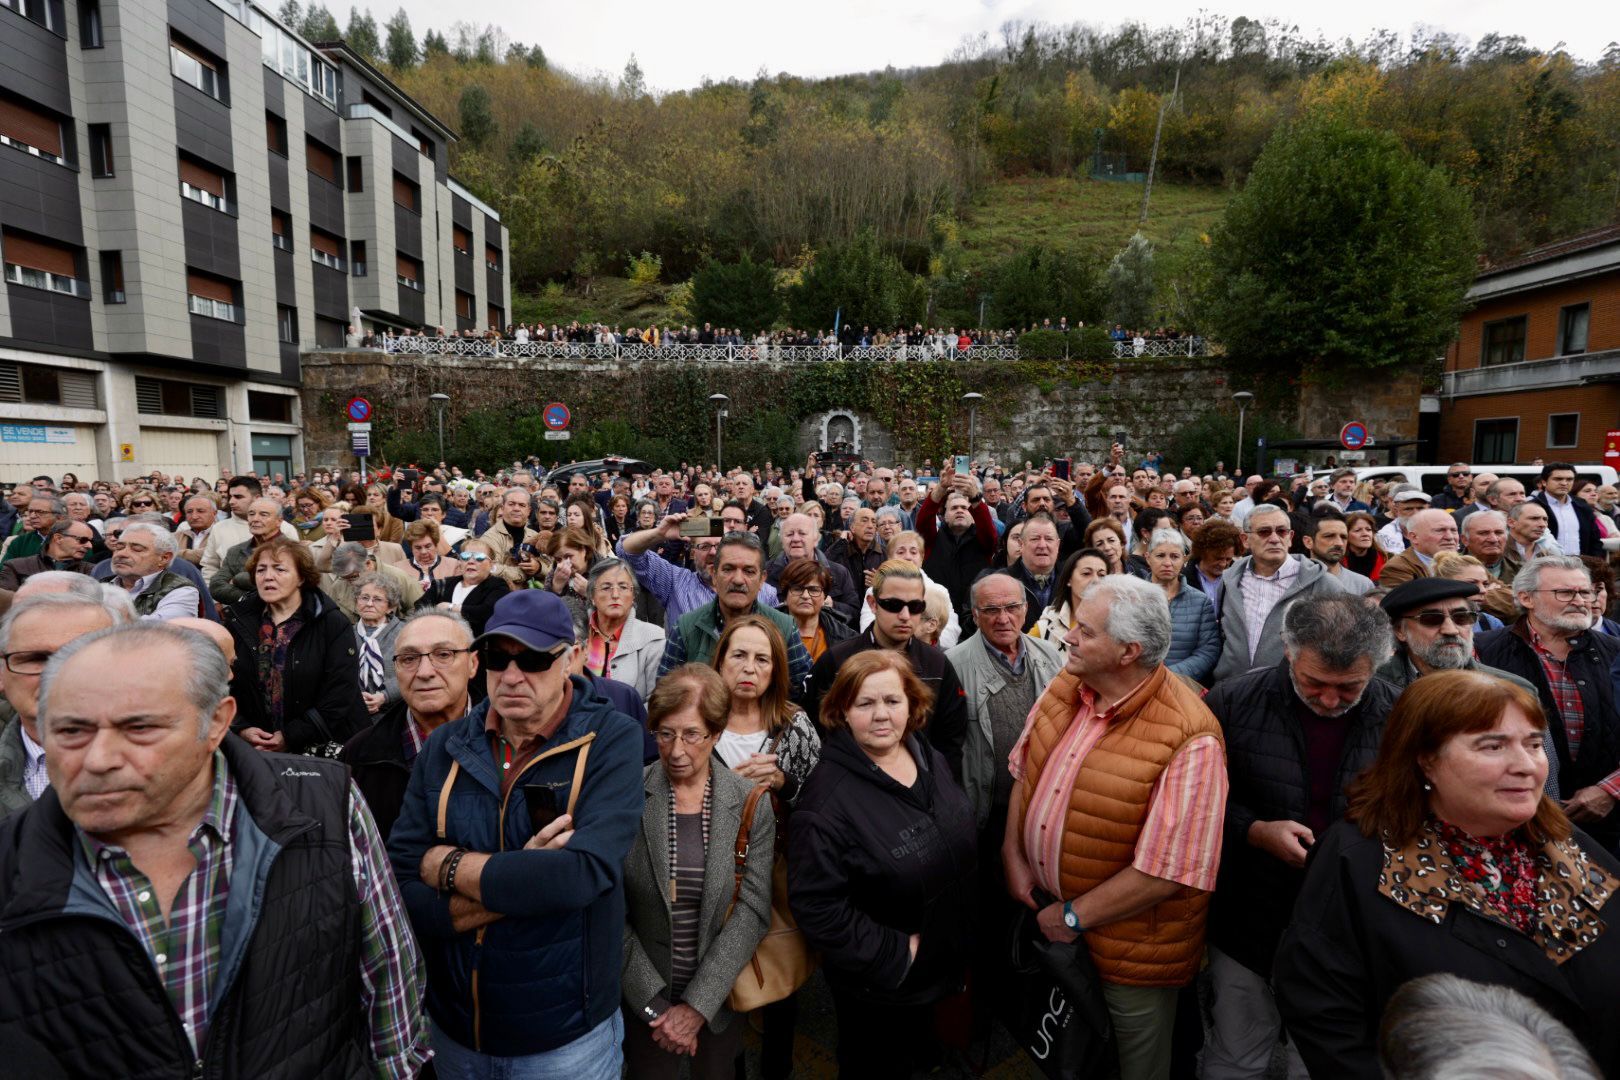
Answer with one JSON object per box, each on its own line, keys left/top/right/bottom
{"left": 282, "top": 0, "right": 1620, "bottom": 333}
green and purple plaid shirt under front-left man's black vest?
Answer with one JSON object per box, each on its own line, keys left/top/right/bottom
{"left": 76, "top": 751, "right": 431, "bottom": 1078}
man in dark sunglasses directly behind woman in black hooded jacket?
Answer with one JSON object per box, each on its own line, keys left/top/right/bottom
{"left": 803, "top": 559, "right": 965, "bottom": 784}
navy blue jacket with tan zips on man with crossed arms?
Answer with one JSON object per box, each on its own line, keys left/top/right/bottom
{"left": 389, "top": 677, "right": 643, "bottom": 1057}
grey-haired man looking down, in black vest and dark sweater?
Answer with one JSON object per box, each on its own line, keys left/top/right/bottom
{"left": 1202, "top": 595, "right": 1399, "bottom": 1080}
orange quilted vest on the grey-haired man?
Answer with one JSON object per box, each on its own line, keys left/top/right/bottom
{"left": 1024, "top": 665, "right": 1221, "bottom": 986}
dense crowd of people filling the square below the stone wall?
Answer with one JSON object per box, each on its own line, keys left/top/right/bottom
{"left": 0, "top": 445, "right": 1620, "bottom": 1080}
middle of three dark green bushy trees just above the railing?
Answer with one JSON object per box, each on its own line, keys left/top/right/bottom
{"left": 787, "top": 228, "right": 927, "bottom": 330}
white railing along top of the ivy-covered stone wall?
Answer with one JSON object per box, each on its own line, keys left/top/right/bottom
{"left": 358, "top": 337, "right": 1209, "bottom": 361}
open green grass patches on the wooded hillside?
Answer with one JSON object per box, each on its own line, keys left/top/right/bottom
{"left": 512, "top": 176, "right": 1228, "bottom": 327}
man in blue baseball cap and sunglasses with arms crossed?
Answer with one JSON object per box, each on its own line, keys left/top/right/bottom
{"left": 389, "top": 589, "right": 643, "bottom": 1080}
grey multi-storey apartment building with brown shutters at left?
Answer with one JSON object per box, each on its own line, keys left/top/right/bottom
{"left": 0, "top": 0, "right": 510, "bottom": 481}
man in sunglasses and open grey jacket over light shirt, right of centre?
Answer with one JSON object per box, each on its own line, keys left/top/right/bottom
{"left": 1215, "top": 502, "right": 1345, "bottom": 683}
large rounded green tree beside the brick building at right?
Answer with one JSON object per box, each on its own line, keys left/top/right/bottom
{"left": 1205, "top": 118, "right": 1479, "bottom": 376}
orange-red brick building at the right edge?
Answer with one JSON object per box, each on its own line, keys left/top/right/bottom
{"left": 1435, "top": 225, "right": 1620, "bottom": 465}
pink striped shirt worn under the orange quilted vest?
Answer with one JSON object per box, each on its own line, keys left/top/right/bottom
{"left": 1008, "top": 683, "right": 1226, "bottom": 900}
